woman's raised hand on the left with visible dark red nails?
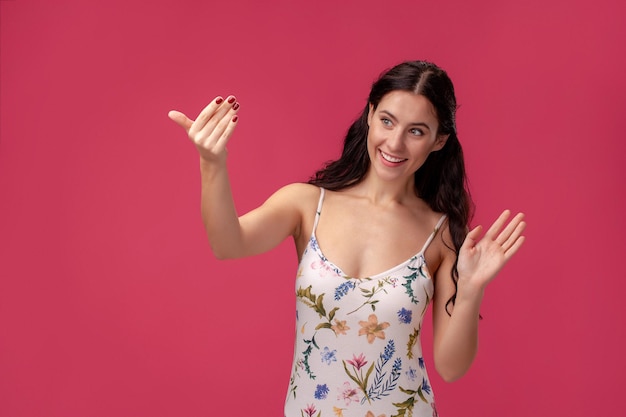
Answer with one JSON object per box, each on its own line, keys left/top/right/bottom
{"left": 168, "top": 96, "right": 239, "bottom": 163}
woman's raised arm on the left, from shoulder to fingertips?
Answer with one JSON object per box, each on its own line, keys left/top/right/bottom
{"left": 169, "top": 96, "right": 302, "bottom": 259}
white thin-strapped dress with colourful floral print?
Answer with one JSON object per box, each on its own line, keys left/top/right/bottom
{"left": 285, "top": 189, "right": 445, "bottom": 417}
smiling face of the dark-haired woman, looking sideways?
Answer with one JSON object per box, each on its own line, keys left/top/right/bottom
{"left": 367, "top": 90, "right": 447, "bottom": 185}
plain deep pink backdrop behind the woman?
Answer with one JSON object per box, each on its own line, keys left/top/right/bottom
{"left": 0, "top": 0, "right": 626, "bottom": 417}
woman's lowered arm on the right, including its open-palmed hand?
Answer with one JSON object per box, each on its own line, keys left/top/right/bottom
{"left": 433, "top": 210, "right": 526, "bottom": 382}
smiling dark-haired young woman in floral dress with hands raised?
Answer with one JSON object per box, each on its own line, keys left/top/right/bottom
{"left": 169, "top": 61, "right": 525, "bottom": 417}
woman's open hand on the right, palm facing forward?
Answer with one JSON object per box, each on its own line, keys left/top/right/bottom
{"left": 457, "top": 210, "right": 526, "bottom": 291}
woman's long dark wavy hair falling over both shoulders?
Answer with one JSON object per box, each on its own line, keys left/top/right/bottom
{"left": 309, "top": 61, "right": 473, "bottom": 314}
